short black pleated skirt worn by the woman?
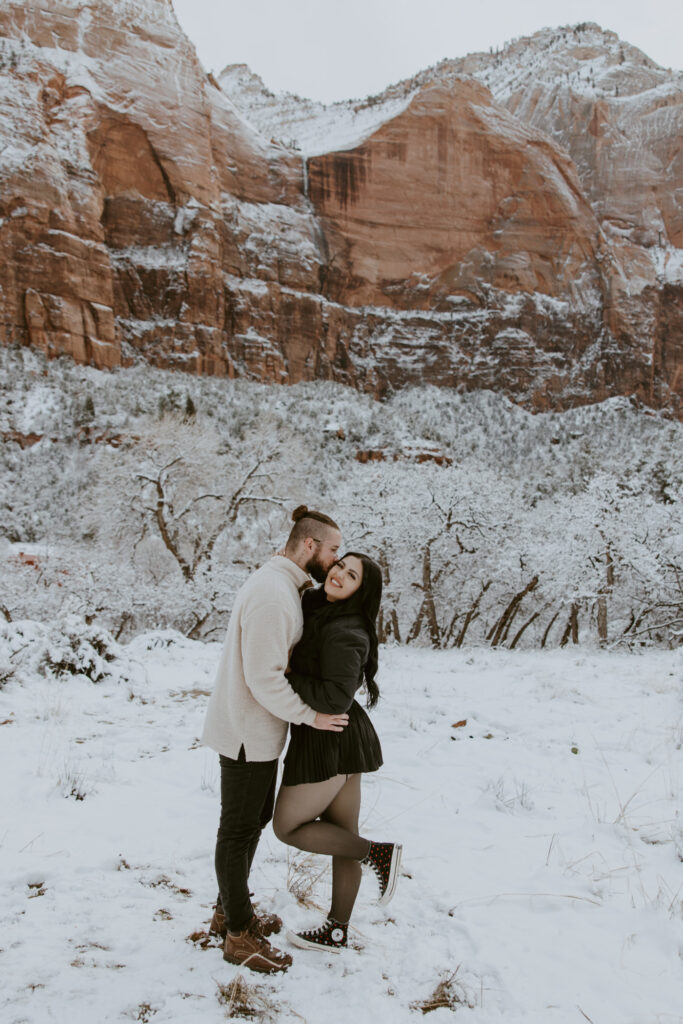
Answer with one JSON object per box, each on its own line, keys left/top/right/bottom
{"left": 283, "top": 700, "right": 382, "bottom": 785}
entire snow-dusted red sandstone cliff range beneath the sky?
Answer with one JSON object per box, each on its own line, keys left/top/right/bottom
{"left": 0, "top": 7, "right": 683, "bottom": 409}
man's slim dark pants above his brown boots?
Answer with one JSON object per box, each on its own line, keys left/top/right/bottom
{"left": 216, "top": 746, "right": 278, "bottom": 933}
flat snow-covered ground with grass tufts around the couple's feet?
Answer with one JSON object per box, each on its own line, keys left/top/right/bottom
{"left": 0, "top": 624, "right": 683, "bottom": 1024}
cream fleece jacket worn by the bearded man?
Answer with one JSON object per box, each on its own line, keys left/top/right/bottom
{"left": 202, "top": 555, "right": 315, "bottom": 761}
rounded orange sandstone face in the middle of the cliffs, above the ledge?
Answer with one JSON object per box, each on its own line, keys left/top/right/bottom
{"left": 308, "top": 81, "right": 600, "bottom": 310}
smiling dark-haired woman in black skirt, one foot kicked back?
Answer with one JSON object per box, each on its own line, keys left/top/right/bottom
{"left": 273, "top": 552, "right": 401, "bottom": 950}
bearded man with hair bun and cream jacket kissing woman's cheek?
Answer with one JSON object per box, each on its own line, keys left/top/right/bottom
{"left": 202, "top": 505, "right": 348, "bottom": 974}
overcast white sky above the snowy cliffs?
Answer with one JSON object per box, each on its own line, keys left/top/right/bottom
{"left": 173, "top": 0, "right": 683, "bottom": 102}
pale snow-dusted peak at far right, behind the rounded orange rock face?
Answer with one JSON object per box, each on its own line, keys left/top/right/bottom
{"left": 466, "top": 24, "right": 683, "bottom": 404}
